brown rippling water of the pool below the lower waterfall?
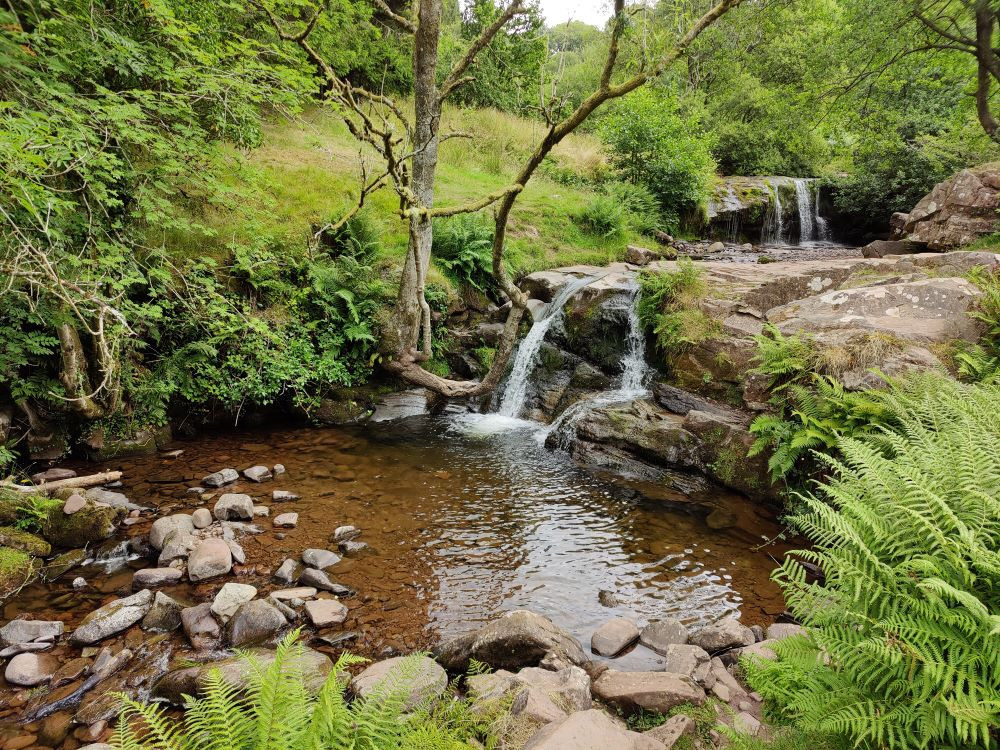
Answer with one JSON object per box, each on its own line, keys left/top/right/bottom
{"left": 3, "top": 416, "right": 786, "bottom": 668}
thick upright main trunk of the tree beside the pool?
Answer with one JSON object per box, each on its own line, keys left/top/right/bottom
{"left": 398, "top": 0, "right": 441, "bottom": 359}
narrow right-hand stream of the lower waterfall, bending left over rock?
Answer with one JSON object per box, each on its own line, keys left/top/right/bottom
{"left": 538, "top": 287, "right": 649, "bottom": 450}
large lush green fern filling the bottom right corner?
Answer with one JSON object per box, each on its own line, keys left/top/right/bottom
{"left": 744, "top": 375, "right": 1000, "bottom": 749}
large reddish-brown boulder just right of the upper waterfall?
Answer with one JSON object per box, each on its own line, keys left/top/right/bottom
{"left": 897, "top": 163, "right": 1000, "bottom": 251}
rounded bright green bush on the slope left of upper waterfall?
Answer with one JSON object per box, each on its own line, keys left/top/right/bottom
{"left": 600, "top": 89, "right": 715, "bottom": 229}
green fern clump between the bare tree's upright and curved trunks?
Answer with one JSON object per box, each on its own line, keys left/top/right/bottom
{"left": 431, "top": 214, "right": 497, "bottom": 296}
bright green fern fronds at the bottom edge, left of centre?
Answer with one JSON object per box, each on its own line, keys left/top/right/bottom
{"left": 113, "top": 632, "right": 491, "bottom": 750}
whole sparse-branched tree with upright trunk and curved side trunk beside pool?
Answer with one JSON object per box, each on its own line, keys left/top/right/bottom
{"left": 251, "top": 0, "right": 741, "bottom": 397}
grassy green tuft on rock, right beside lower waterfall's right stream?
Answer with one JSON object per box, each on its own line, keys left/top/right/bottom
{"left": 637, "top": 258, "right": 718, "bottom": 361}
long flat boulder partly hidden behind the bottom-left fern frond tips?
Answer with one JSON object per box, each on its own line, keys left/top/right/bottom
{"left": 153, "top": 648, "right": 333, "bottom": 705}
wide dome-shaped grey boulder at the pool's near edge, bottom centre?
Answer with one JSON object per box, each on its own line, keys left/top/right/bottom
{"left": 437, "top": 609, "right": 587, "bottom": 672}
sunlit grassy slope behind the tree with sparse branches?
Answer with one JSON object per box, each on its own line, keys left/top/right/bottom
{"left": 165, "top": 108, "right": 641, "bottom": 282}
